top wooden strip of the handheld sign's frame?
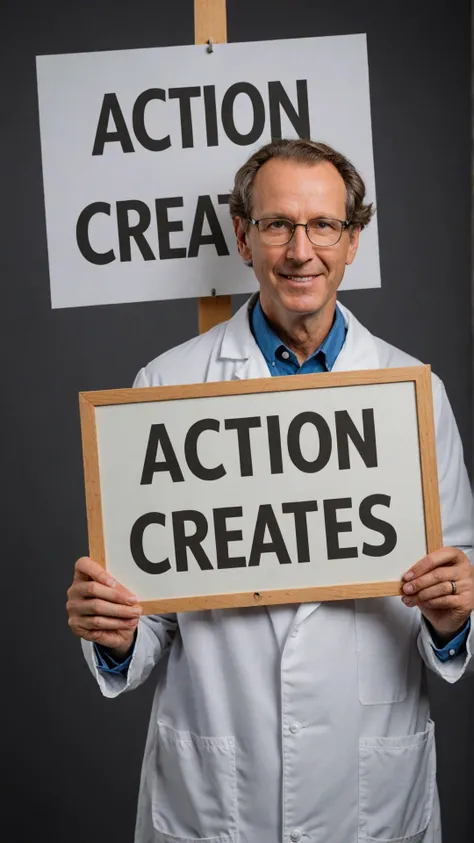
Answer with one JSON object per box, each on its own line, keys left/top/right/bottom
{"left": 81, "top": 366, "right": 429, "bottom": 408}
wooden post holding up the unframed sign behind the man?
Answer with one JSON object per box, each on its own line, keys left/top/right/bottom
{"left": 194, "top": 0, "right": 231, "bottom": 334}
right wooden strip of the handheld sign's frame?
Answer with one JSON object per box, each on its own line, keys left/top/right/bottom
{"left": 415, "top": 366, "right": 443, "bottom": 553}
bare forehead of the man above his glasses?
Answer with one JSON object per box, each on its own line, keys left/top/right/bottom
{"left": 252, "top": 158, "right": 346, "bottom": 210}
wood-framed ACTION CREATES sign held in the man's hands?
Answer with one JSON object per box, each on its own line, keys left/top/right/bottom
{"left": 80, "top": 366, "right": 442, "bottom": 614}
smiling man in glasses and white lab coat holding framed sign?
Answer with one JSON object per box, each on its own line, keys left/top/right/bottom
{"left": 68, "top": 140, "right": 474, "bottom": 843}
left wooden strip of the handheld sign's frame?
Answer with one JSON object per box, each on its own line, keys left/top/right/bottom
{"left": 79, "top": 393, "right": 105, "bottom": 568}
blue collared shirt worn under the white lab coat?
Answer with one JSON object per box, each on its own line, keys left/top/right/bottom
{"left": 94, "top": 299, "right": 471, "bottom": 675}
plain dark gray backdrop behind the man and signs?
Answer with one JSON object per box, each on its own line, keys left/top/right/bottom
{"left": 0, "top": 0, "right": 474, "bottom": 843}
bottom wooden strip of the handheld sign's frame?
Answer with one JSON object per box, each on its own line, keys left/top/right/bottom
{"left": 140, "top": 580, "right": 402, "bottom": 615}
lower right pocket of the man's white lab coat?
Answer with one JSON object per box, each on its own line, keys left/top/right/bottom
{"left": 358, "top": 720, "right": 436, "bottom": 843}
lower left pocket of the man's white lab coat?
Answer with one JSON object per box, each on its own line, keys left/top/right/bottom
{"left": 152, "top": 721, "right": 238, "bottom": 843}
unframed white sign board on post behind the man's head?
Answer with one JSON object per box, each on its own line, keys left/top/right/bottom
{"left": 37, "top": 35, "right": 380, "bottom": 308}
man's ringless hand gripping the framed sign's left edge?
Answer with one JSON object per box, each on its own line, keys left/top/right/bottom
{"left": 66, "top": 556, "right": 142, "bottom": 660}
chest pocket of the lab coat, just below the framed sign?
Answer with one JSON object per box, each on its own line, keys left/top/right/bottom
{"left": 354, "top": 597, "right": 414, "bottom": 705}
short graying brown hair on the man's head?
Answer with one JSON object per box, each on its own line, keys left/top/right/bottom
{"left": 229, "top": 138, "right": 375, "bottom": 229}
